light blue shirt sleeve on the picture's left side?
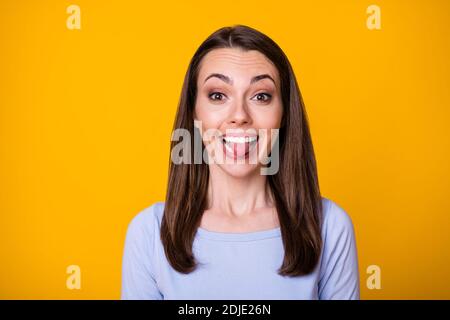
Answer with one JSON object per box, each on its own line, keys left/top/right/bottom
{"left": 121, "top": 207, "right": 163, "bottom": 300}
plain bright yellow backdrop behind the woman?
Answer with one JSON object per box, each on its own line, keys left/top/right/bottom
{"left": 0, "top": 0, "right": 450, "bottom": 299}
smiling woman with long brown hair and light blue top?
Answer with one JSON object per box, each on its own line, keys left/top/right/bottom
{"left": 121, "top": 25, "right": 359, "bottom": 299}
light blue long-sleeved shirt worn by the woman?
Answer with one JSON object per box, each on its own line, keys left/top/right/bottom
{"left": 121, "top": 198, "right": 359, "bottom": 300}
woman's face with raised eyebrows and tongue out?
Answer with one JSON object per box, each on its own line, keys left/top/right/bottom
{"left": 195, "top": 48, "right": 283, "bottom": 177}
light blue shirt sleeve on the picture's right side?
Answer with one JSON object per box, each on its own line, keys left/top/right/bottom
{"left": 319, "top": 200, "right": 360, "bottom": 300}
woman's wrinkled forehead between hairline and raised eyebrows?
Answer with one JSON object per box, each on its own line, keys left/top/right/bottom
{"left": 198, "top": 48, "right": 278, "bottom": 83}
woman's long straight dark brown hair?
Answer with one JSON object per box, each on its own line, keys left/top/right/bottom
{"left": 160, "top": 25, "right": 322, "bottom": 276}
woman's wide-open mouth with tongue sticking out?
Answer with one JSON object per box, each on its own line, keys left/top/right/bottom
{"left": 221, "top": 135, "right": 259, "bottom": 160}
